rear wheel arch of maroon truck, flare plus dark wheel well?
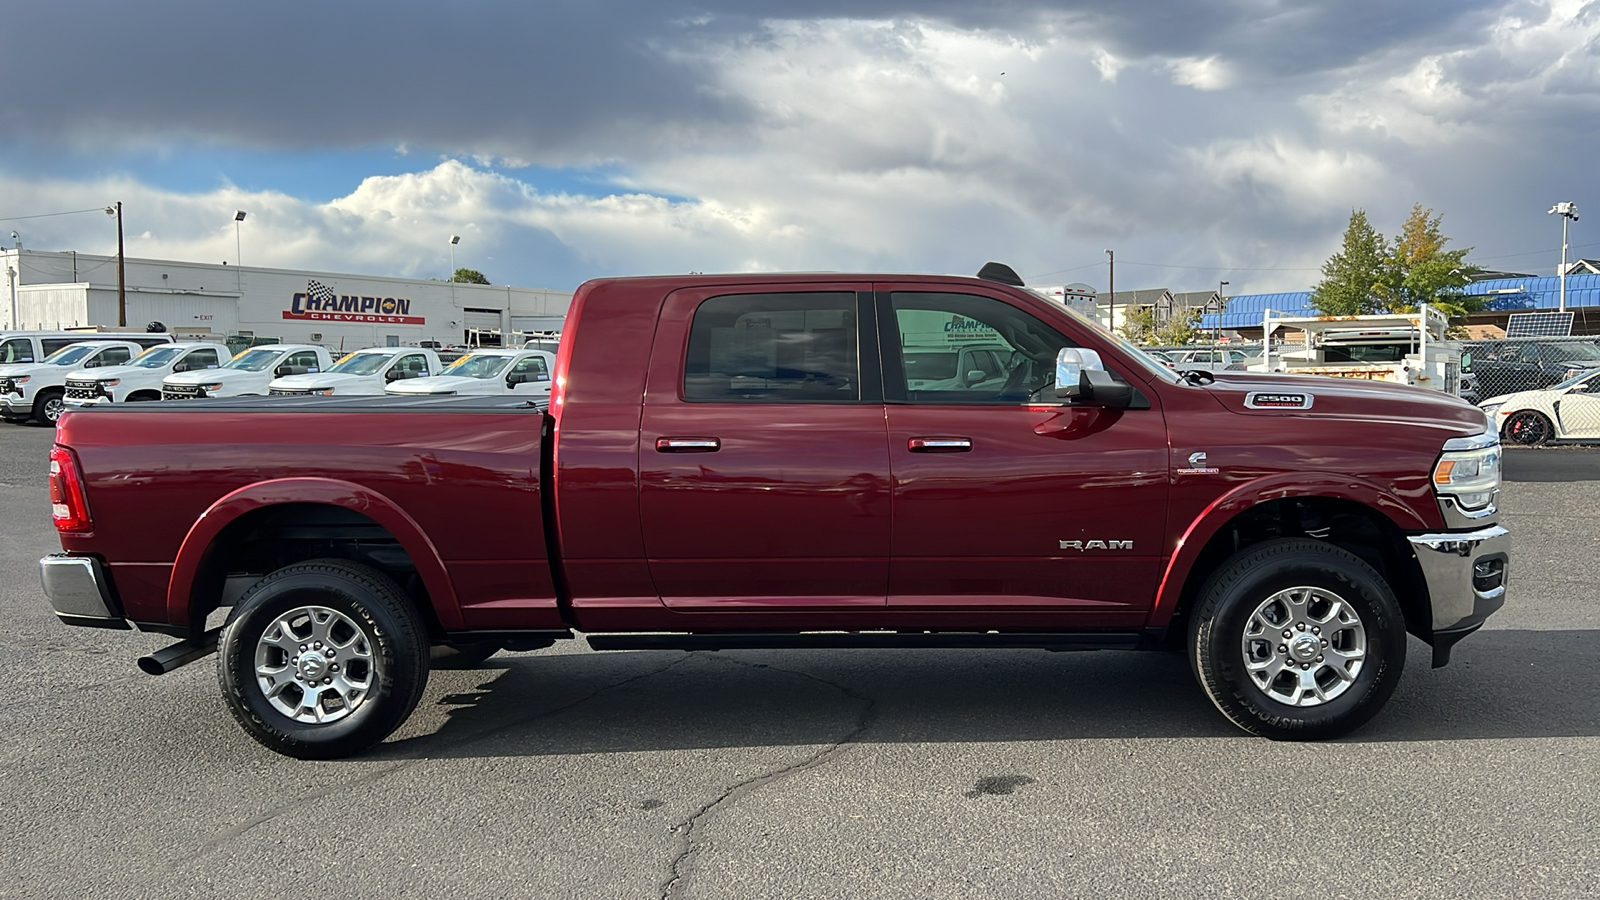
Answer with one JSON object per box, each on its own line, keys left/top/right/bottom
{"left": 166, "top": 477, "right": 464, "bottom": 633}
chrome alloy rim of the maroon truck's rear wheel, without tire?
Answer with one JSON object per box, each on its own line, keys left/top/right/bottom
{"left": 256, "top": 607, "right": 382, "bottom": 724}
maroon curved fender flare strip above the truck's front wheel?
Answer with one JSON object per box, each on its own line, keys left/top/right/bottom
{"left": 1146, "top": 472, "right": 1434, "bottom": 628}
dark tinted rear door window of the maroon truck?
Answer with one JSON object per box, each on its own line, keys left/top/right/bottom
{"left": 683, "top": 291, "right": 861, "bottom": 404}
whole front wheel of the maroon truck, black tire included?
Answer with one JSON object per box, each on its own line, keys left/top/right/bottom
{"left": 1189, "top": 538, "right": 1406, "bottom": 740}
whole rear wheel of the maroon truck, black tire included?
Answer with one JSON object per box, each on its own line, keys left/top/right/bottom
{"left": 218, "top": 559, "right": 429, "bottom": 759}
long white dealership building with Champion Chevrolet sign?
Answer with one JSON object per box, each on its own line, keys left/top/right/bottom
{"left": 0, "top": 248, "right": 573, "bottom": 351}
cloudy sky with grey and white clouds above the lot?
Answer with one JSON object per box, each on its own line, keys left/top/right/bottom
{"left": 0, "top": 0, "right": 1600, "bottom": 293}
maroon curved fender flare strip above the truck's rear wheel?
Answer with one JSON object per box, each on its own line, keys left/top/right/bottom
{"left": 166, "top": 477, "right": 466, "bottom": 629}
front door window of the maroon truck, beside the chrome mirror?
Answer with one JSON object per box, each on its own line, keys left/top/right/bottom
{"left": 883, "top": 293, "right": 1077, "bottom": 404}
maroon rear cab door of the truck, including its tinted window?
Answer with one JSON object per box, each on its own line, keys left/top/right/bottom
{"left": 638, "top": 283, "right": 890, "bottom": 610}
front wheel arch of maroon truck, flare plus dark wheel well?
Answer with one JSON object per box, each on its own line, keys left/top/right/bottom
{"left": 1149, "top": 477, "right": 1435, "bottom": 645}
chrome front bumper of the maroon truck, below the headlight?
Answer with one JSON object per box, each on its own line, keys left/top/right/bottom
{"left": 1406, "top": 525, "right": 1510, "bottom": 668}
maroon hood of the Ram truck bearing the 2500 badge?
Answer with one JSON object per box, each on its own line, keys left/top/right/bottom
{"left": 1205, "top": 372, "right": 1488, "bottom": 436}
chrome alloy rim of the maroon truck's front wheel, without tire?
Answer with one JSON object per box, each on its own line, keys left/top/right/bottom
{"left": 1242, "top": 588, "right": 1366, "bottom": 706}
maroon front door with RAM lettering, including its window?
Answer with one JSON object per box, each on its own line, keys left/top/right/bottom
{"left": 877, "top": 283, "right": 1168, "bottom": 628}
